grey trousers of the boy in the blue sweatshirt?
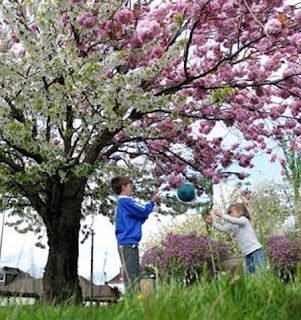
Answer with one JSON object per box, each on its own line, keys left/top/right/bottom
{"left": 118, "top": 244, "right": 140, "bottom": 297}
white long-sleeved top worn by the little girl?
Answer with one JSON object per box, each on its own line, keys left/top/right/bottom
{"left": 212, "top": 214, "right": 261, "bottom": 256}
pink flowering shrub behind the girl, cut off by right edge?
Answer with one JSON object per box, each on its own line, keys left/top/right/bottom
{"left": 267, "top": 235, "right": 301, "bottom": 280}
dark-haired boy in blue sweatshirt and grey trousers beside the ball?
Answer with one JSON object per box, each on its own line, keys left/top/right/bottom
{"left": 111, "top": 176, "right": 161, "bottom": 296}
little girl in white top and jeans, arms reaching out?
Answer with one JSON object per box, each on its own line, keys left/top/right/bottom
{"left": 205, "top": 203, "right": 266, "bottom": 274}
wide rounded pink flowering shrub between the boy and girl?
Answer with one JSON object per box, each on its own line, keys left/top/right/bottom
{"left": 142, "top": 233, "right": 228, "bottom": 283}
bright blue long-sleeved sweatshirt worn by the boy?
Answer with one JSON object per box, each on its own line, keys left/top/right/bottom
{"left": 115, "top": 196, "right": 155, "bottom": 245}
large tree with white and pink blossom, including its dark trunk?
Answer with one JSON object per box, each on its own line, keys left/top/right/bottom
{"left": 0, "top": 0, "right": 301, "bottom": 301}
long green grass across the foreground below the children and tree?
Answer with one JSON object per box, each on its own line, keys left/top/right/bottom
{"left": 0, "top": 274, "right": 301, "bottom": 320}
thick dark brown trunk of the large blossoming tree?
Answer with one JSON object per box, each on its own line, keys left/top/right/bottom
{"left": 43, "top": 179, "right": 86, "bottom": 303}
